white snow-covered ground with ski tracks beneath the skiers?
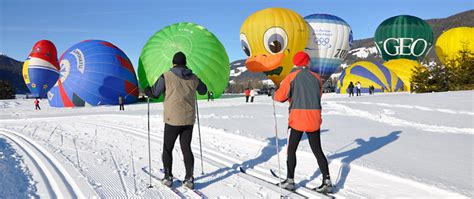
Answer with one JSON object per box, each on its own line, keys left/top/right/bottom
{"left": 0, "top": 91, "right": 474, "bottom": 198}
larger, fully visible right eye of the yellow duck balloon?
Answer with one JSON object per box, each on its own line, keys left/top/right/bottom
{"left": 263, "top": 27, "right": 288, "bottom": 54}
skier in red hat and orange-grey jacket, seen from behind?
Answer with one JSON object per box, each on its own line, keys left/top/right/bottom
{"left": 273, "top": 51, "right": 333, "bottom": 193}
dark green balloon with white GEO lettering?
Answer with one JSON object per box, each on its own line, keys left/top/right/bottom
{"left": 375, "top": 15, "right": 433, "bottom": 61}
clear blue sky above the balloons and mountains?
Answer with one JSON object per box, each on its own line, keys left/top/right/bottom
{"left": 0, "top": 0, "right": 474, "bottom": 67}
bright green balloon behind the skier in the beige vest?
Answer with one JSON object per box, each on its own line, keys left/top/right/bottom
{"left": 138, "top": 23, "right": 230, "bottom": 100}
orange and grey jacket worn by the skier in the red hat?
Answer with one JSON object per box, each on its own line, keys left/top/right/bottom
{"left": 273, "top": 66, "right": 323, "bottom": 133}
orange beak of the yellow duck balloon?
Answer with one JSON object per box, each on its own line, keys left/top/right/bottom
{"left": 245, "top": 53, "right": 285, "bottom": 76}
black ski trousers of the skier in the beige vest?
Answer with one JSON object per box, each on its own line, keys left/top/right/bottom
{"left": 162, "top": 124, "right": 194, "bottom": 179}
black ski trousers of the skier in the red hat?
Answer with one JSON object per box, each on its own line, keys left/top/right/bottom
{"left": 286, "top": 129, "right": 329, "bottom": 179}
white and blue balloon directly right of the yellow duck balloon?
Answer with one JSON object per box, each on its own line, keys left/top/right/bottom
{"left": 304, "top": 14, "right": 352, "bottom": 81}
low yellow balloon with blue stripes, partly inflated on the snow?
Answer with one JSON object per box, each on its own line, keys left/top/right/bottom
{"left": 336, "top": 61, "right": 403, "bottom": 94}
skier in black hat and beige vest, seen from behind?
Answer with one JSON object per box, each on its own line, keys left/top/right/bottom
{"left": 145, "top": 52, "right": 207, "bottom": 189}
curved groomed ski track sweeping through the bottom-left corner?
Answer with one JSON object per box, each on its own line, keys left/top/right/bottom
{"left": 0, "top": 128, "right": 86, "bottom": 198}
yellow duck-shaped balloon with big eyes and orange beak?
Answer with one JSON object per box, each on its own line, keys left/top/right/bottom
{"left": 240, "top": 8, "right": 309, "bottom": 85}
